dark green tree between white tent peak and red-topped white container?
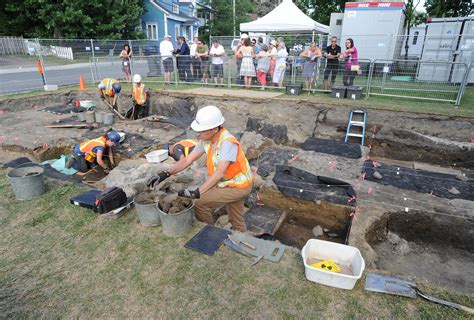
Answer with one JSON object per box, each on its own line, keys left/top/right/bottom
{"left": 295, "top": 0, "right": 350, "bottom": 25}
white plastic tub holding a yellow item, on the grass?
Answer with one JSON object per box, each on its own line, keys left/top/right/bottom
{"left": 301, "top": 239, "right": 365, "bottom": 290}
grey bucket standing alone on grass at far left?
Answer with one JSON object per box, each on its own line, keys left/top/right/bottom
{"left": 7, "top": 162, "right": 46, "bottom": 200}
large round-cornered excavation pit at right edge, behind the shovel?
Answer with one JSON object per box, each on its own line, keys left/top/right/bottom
{"left": 366, "top": 211, "right": 474, "bottom": 294}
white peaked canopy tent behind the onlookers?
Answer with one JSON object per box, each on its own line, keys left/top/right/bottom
{"left": 240, "top": 0, "right": 329, "bottom": 33}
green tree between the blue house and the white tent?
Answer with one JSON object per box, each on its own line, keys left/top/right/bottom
{"left": 210, "top": 0, "right": 254, "bottom": 36}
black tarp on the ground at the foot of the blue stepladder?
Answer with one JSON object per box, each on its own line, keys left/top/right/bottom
{"left": 301, "top": 138, "right": 362, "bottom": 159}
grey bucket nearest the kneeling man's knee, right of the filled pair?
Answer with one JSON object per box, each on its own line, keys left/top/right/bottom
{"left": 156, "top": 202, "right": 194, "bottom": 237}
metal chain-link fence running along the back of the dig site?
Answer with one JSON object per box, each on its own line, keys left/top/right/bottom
{"left": 0, "top": 34, "right": 473, "bottom": 105}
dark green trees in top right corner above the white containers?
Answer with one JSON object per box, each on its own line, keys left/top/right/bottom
{"left": 425, "top": 0, "right": 473, "bottom": 18}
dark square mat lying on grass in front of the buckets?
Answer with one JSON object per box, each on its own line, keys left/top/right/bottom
{"left": 184, "top": 225, "right": 232, "bottom": 256}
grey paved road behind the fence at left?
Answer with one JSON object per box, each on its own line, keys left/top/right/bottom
{"left": 0, "top": 61, "right": 148, "bottom": 95}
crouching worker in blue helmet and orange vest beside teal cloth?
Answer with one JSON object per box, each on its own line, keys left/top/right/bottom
{"left": 66, "top": 131, "right": 120, "bottom": 172}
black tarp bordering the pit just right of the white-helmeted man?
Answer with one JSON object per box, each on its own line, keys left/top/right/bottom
{"left": 273, "top": 165, "right": 356, "bottom": 206}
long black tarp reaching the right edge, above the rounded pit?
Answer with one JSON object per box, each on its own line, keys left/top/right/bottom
{"left": 363, "top": 160, "right": 474, "bottom": 201}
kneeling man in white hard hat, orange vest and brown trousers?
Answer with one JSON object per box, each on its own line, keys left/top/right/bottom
{"left": 147, "top": 106, "right": 253, "bottom": 232}
